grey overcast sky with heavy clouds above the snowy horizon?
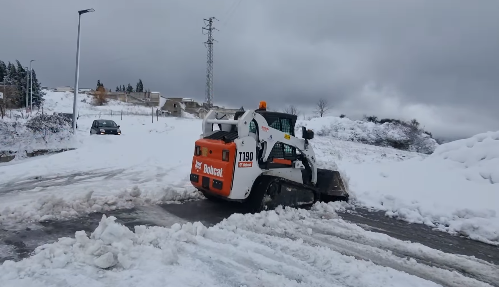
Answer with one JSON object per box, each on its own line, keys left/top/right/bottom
{"left": 0, "top": 0, "right": 499, "bottom": 140}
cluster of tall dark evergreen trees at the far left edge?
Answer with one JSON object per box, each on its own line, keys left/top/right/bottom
{"left": 0, "top": 60, "right": 45, "bottom": 108}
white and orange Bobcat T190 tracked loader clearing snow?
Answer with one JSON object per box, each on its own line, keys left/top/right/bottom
{"left": 190, "top": 102, "right": 349, "bottom": 212}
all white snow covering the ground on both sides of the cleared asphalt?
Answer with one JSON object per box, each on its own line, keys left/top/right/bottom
{"left": 0, "top": 93, "right": 499, "bottom": 286}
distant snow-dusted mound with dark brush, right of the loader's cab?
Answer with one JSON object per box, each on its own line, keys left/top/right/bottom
{"left": 296, "top": 116, "right": 438, "bottom": 154}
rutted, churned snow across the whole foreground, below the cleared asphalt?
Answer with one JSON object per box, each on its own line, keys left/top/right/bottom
{"left": 0, "top": 204, "right": 499, "bottom": 287}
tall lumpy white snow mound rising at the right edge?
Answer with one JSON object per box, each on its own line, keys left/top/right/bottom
{"left": 432, "top": 131, "right": 499, "bottom": 186}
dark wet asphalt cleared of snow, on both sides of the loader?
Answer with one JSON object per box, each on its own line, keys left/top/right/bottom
{"left": 0, "top": 200, "right": 499, "bottom": 270}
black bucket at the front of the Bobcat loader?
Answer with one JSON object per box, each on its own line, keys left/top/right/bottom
{"left": 317, "top": 168, "right": 349, "bottom": 202}
